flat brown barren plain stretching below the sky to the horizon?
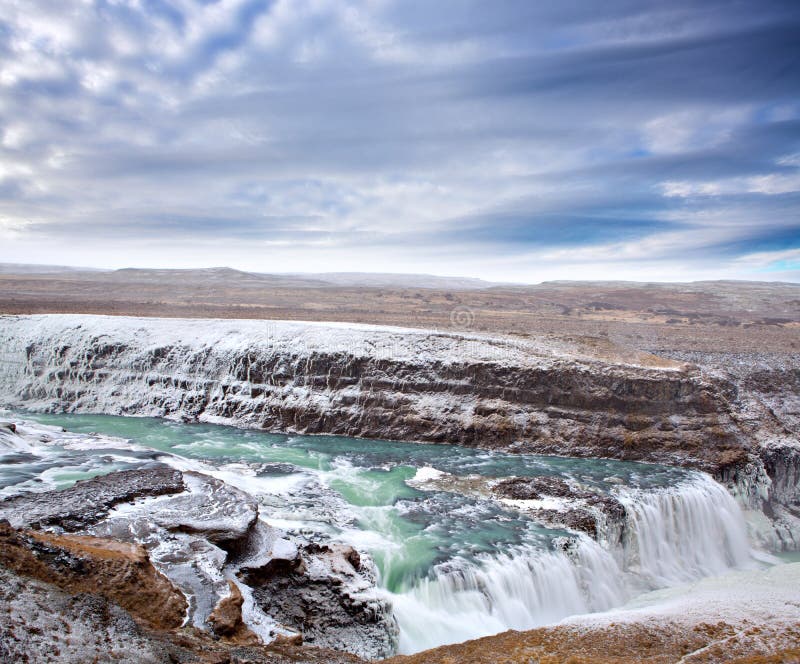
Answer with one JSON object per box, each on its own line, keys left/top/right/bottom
{"left": 0, "top": 265, "right": 800, "bottom": 353}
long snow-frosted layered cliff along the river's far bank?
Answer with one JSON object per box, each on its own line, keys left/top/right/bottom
{"left": 0, "top": 315, "right": 800, "bottom": 548}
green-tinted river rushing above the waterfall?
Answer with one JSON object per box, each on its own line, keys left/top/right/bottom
{"left": 0, "top": 414, "right": 685, "bottom": 591}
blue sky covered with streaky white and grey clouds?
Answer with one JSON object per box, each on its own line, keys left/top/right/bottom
{"left": 0, "top": 0, "right": 800, "bottom": 282}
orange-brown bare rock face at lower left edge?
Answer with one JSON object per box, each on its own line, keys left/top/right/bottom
{"left": 0, "top": 521, "right": 186, "bottom": 629}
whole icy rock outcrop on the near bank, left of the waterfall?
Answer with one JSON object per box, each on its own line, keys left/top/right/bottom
{"left": 0, "top": 466, "right": 397, "bottom": 661}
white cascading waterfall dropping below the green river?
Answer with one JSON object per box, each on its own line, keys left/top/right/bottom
{"left": 392, "top": 473, "right": 751, "bottom": 653}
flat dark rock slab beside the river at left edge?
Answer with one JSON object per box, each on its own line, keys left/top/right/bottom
{"left": 0, "top": 466, "right": 185, "bottom": 532}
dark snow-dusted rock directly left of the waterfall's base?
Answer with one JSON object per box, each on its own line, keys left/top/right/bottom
{"left": 241, "top": 543, "right": 398, "bottom": 659}
